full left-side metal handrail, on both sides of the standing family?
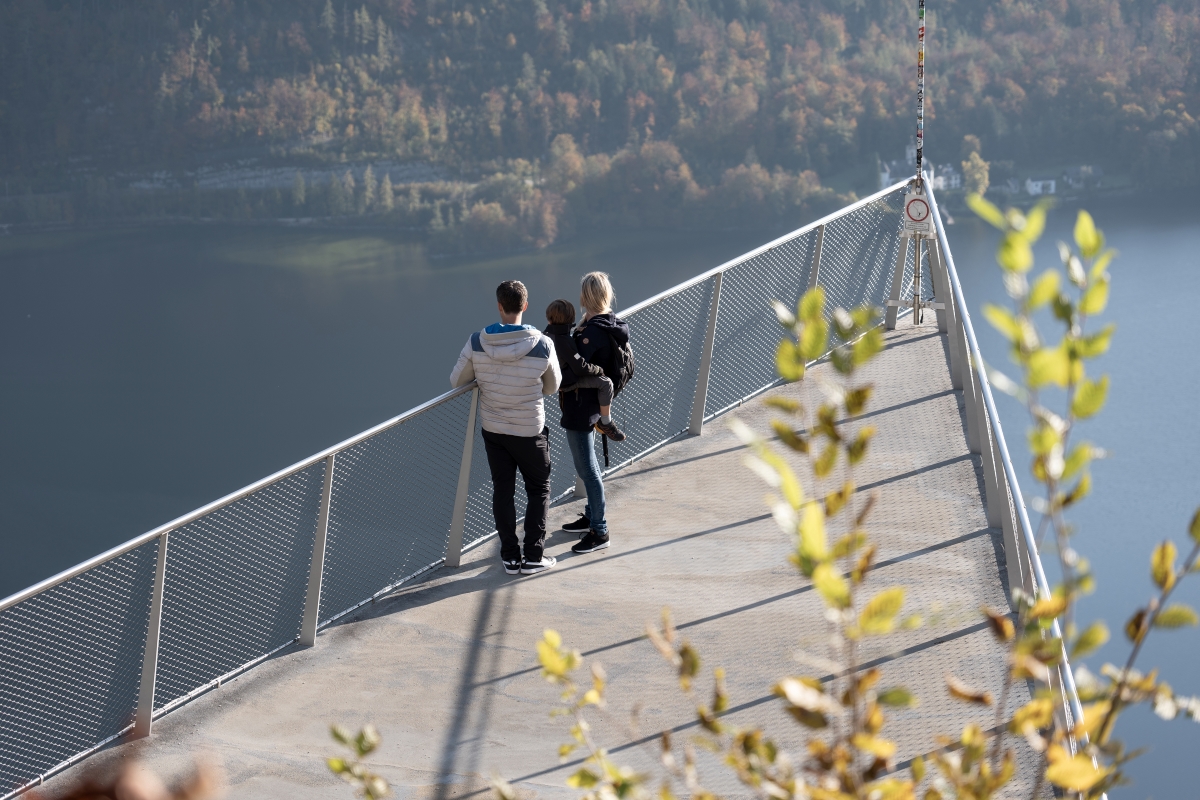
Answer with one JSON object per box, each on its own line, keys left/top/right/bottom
{"left": 0, "top": 181, "right": 906, "bottom": 612}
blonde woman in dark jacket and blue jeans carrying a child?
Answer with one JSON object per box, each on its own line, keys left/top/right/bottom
{"left": 558, "top": 272, "right": 629, "bottom": 553}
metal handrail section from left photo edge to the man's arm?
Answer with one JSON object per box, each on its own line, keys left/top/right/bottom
{"left": 0, "top": 380, "right": 475, "bottom": 612}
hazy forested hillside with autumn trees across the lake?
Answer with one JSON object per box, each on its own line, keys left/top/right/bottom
{"left": 0, "top": 0, "right": 1200, "bottom": 247}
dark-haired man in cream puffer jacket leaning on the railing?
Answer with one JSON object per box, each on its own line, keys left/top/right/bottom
{"left": 450, "top": 281, "right": 562, "bottom": 575}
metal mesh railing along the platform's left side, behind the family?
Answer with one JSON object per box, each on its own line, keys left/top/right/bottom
{"left": 0, "top": 178, "right": 1022, "bottom": 798}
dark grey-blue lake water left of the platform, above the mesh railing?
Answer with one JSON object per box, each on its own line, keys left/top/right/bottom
{"left": 0, "top": 225, "right": 763, "bottom": 596}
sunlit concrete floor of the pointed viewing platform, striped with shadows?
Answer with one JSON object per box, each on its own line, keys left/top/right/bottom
{"left": 48, "top": 314, "right": 1046, "bottom": 800}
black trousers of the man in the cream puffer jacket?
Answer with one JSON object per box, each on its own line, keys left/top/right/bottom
{"left": 484, "top": 428, "right": 550, "bottom": 561}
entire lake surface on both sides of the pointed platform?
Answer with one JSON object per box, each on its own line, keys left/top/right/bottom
{"left": 0, "top": 196, "right": 1200, "bottom": 799}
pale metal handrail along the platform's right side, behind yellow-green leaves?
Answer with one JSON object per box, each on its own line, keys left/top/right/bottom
{"left": 925, "top": 181, "right": 1084, "bottom": 734}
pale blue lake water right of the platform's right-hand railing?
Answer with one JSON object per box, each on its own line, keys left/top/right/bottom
{"left": 949, "top": 194, "right": 1200, "bottom": 800}
